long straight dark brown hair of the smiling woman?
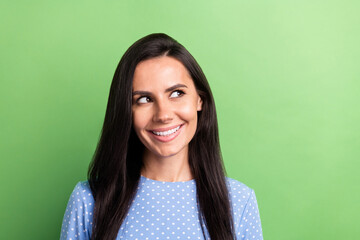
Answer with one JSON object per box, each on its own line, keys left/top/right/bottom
{"left": 88, "top": 33, "right": 236, "bottom": 240}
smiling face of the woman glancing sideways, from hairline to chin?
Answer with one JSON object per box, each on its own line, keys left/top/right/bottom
{"left": 132, "top": 56, "right": 202, "bottom": 157}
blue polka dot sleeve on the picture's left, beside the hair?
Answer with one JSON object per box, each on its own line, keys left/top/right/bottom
{"left": 60, "top": 181, "right": 94, "bottom": 240}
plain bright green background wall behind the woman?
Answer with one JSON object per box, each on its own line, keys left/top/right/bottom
{"left": 0, "top": 0, "right": 360, "bottom": 240}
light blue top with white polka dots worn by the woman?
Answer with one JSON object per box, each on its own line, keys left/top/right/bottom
{"left": 60, "top": 176, "right": 263, "bottom": 240}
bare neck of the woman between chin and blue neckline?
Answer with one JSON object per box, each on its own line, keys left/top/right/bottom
{"left": 141, "top": 150, "right": 193, "bottom": 182}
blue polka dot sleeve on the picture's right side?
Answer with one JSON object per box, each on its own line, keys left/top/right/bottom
{"left": 237, "top": 189, "right": 263, "bottom": 240}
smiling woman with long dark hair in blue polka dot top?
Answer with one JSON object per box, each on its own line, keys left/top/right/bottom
{"left": 61, "top": 34, "right": 262, "bottom": 240}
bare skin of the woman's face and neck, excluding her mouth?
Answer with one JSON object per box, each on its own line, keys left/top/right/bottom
{"left": 132, "top": 56, "right": 202, "bottom": 182}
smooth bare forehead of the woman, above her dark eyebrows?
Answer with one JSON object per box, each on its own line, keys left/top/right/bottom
{"left": 133, "top": 56, "right": 193, "bottom": 90}
